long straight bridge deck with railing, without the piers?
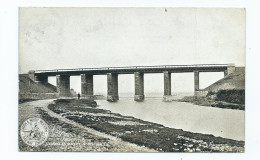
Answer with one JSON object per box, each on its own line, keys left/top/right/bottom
{"left": 33, "top": 64, "right": 228, "bottom": 76}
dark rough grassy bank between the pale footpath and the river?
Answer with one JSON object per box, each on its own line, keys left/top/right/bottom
{"left": 48, "top": 99, "right": 244, "bottom": 152}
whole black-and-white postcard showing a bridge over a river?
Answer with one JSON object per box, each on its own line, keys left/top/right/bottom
{"left": 18, "top": 7, "right": 246, "bottom": 153}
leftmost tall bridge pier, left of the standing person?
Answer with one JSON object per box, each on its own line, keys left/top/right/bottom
{"left": 56, "top": 75, "right": 71, "bottom": 97}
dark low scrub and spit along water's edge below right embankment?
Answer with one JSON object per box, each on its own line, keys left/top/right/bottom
{"left": 178, "top": 89, "right": 245, "bottom": 110}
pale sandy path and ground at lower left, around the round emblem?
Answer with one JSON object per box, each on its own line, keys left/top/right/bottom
{"left": 19, "top": 99, "right": 156, "bottom": 152}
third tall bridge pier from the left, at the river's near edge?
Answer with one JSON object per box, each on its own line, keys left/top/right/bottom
{"left": 107, "top": 73, "right": 119, "bottom": 102}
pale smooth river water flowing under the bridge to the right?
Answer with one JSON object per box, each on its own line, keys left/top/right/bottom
{"left": 97, "top": 98, "right": 245, "bottom": 140}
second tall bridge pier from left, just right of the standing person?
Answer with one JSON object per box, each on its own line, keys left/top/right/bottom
{"left": 80, "top": 74, "right": 94, "bottom": 98}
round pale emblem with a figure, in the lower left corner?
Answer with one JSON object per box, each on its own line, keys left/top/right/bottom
{"left": 20, "top": 118, "right": 49, "bottom": 147}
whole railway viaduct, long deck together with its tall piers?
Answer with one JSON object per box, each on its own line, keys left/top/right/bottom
{"left": 29, "top": 64, "right": 235, "bottom": 101}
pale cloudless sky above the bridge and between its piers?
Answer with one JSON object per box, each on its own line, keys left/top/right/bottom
{"left": 19, "top": 8, "right": 245, "bottom": 93}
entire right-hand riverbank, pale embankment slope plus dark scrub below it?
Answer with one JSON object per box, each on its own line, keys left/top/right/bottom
{"left": 178, "top": 67, "right": 245, "bottom": 110}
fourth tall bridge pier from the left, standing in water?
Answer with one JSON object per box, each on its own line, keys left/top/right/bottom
{"left": 134, "top": 72, "right": 144, "bottom": 101}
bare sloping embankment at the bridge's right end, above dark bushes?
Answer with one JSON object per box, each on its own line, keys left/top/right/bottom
{"left": 204, "top": 67, "right": 245, "bottom": 92}
